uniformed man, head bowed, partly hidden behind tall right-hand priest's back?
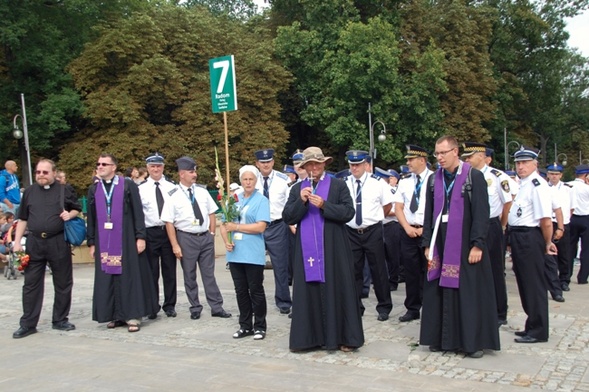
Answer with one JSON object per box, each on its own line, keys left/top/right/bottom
{"left": 462, "top": 142, "right": 513, "bottom": 325}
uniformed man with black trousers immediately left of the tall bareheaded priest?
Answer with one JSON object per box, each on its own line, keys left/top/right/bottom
{"left": 394, "top": 144, "right": 432, "bottom": 322}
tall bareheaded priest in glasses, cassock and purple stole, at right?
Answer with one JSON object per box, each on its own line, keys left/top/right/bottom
{"left": 420, "top": 136, "right": 500, "bottom": 358}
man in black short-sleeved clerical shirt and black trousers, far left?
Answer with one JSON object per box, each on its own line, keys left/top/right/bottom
{"left": 12, "top": 159, "right": 82, "bottom": 339}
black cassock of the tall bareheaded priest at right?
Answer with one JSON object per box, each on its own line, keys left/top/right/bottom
{"left": 420, "top": 169, "right": 500, "bottom": 353}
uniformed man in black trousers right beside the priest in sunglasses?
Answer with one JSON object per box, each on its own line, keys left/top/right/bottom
{"left": 139, "top": 152, "right": 177, "bottom": 319}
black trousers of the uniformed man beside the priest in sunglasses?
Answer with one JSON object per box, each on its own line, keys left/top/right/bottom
{"left": 145, "top": 226, "right": 178, "bottom": 312}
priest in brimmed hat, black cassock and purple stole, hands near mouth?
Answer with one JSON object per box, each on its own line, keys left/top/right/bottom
{"left": 282, "top": 147, "right": 364, "bottom": 352}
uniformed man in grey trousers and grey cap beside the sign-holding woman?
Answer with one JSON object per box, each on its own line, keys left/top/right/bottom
{"left": 161, "top": 157, "right": 231, "bottom": 320}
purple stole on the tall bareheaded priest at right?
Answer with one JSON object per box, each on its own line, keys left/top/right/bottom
{"left": 427, "top": 162, "right": 470, "bottom": 289}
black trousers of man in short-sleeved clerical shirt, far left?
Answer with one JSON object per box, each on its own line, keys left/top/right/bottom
{"left": 20, "top": 233, "right": 74, "bottom": 327}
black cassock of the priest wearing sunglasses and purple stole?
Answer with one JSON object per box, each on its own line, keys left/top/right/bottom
{"left": 87, "top": 179, "right": 159, "bottom": 323}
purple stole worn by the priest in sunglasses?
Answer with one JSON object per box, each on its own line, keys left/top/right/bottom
{"left": 94, "top": 176, "right": 125, "bottom": 275}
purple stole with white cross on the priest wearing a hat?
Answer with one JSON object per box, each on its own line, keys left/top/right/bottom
{"left": 299, "top": 175, "right": 331, "bottom": 283}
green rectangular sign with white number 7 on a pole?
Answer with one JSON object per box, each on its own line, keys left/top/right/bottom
{"left": 209, "top": 55, "right": 237, "bottom": 113}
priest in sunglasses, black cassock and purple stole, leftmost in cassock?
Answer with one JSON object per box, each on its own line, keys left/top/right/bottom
{"left": 87, "top": 154, "right": 158, "bottom": 332}
